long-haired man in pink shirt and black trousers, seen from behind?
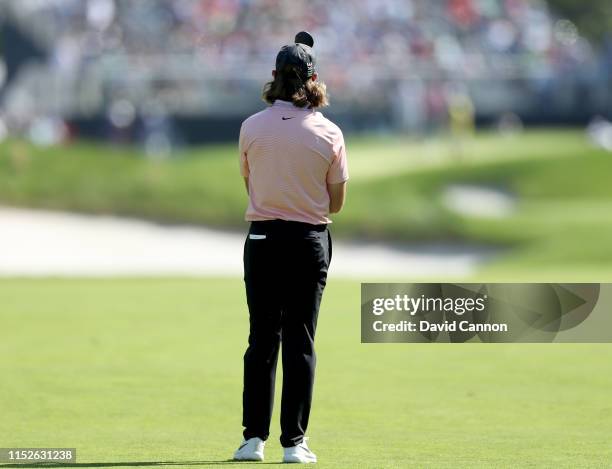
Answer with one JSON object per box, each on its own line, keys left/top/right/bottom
{"left": 234, "top": 32, "right": 348, "bottom": 463}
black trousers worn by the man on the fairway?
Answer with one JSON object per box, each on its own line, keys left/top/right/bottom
{"left": 242, "top": 220, "right": 332, "bottom": 447}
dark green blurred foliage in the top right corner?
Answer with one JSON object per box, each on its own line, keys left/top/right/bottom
{"left": 548, "top": 0, "right": 612, "bottom": 44}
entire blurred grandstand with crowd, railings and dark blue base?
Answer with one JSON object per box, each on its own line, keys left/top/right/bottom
{"left": 0, "top": 0, "right": 612, "bottom": 146}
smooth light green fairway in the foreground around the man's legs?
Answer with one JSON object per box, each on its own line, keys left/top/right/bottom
{"left": 0, "top": 279, "right": 612, "bottom": 469}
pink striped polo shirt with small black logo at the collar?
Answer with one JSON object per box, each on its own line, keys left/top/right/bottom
{"left": 240, "top": 100, "right": 349, "bottom": 224}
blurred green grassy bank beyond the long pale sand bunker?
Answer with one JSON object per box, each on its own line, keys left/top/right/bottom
{"left": 0, "top": 129, "right": 612, "bottom": 274}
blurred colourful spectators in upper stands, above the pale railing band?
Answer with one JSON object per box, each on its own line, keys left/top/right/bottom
{"left": 13, "top": 0, "right": 590, "bottom": 77}
